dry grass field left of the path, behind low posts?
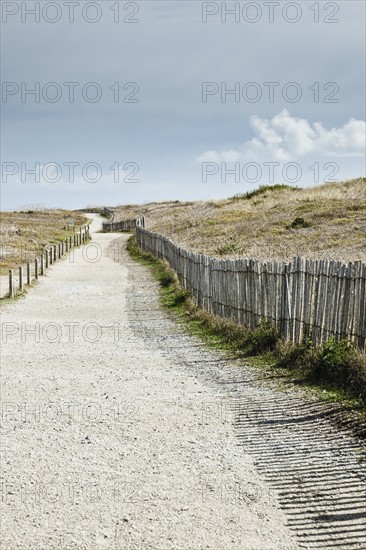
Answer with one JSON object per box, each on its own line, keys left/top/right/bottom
{"left": 0, "top": 208, "right": 86, "bottom": 275}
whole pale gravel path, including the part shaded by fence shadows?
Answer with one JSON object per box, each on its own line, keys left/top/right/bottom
{"left": 1, "top": 216, "right": 366, "bottom": 550}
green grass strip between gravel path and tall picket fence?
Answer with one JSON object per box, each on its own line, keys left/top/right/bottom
{"left": 127, "top": 237, "right": 366, "bottom": 422}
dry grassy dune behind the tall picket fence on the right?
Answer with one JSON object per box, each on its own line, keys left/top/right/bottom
{"left": 116, "top": 178, "right": 366, "bottom": 262}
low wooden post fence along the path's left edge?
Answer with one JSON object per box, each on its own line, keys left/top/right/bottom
{"left": 8, "top": 225, "right": 90, "bottom": 298}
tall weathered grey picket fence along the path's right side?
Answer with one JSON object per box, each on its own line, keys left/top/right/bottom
{"left": 136, "top": 226, "right": 366, "bottom": 349}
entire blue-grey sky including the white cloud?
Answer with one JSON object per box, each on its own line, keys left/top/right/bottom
{"left": 1, "top": 0, "right": 366, "bottom": 210}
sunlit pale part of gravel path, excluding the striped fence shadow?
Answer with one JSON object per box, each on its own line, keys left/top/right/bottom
{"left": 1, "top": 217, "right": 298, "bottom": 550}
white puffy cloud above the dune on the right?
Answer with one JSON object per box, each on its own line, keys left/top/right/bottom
{"left": 197, "top": 109, "right": 366, "bottom": 162}
